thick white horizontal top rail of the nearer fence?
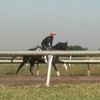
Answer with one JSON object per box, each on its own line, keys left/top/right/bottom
{"left": 0, "top": 51, "right": 100, "bottom": 55}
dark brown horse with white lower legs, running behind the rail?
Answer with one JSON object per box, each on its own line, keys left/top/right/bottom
{"left": 11, "top": 42, "right": 68, "bottom": 76}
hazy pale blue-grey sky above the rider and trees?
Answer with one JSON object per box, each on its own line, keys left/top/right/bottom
{"left": 0, "top": 0, "right": 100, "bottom": 50}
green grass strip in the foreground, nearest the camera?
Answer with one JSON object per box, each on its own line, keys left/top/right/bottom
{"left": 0, "top": 83, "right": 100, "bottom": 100}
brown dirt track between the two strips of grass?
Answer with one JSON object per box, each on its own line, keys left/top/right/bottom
{"left": 0, "top": 75, "right": 100, "bottom": 86}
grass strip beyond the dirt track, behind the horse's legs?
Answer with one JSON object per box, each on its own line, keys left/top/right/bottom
{"left": 0, "top": 64, "right": 100, "bottom": 75}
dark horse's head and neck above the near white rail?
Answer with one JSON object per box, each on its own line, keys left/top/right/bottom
{"left": 53, "top": 42, "right": 68, "bottom": 50}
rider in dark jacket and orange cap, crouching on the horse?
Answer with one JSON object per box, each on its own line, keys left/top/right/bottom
{"left": 41, "top": 32, "right": 56, "bottom": 62}
